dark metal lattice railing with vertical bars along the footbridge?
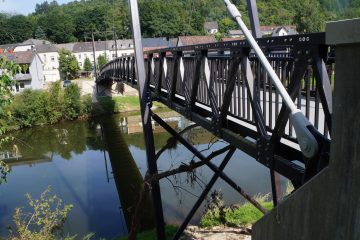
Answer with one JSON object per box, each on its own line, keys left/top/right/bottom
{"left": 98, "top": 33, "right": 334, "bottom": 144}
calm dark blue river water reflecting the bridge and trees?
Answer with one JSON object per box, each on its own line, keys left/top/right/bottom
{"left": 0, "top": 112, "right": 286, "bottom": 238}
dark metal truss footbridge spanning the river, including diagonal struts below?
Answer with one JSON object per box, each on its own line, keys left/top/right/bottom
{"left": 97, "top": 33, "right": 335, "bottom": 238}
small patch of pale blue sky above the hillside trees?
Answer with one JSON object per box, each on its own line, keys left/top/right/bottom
{"left": 0, "top": 0, "right": 73, "bottom": 15}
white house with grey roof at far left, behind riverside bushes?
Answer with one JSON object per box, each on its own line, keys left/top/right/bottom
{"left": 0, "top": 51, "right": 44, "bottom": 92}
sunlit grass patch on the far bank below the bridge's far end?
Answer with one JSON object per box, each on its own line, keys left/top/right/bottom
{"left": 98, "top": 96, "right": 165, "bottom": 113}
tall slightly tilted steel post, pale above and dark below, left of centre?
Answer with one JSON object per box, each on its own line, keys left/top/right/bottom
{"left": 129, "top": 0, "right": 165, "bottom": 240}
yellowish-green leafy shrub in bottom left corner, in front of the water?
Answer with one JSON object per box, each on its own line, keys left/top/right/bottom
{"left": 8, "top": 187, "right": 93, "bottom": 240}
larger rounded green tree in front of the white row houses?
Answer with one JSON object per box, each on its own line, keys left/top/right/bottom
{"left": 59, "top": 49, "right": 80, "bottom": 79}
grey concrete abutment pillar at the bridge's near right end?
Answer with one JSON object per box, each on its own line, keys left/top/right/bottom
{"left": 253, "top": 19, "right": 360, "bottom": 240}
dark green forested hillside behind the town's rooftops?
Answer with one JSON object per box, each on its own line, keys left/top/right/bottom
{"left": 0, "top": 0, "right": 360, "bottom": 44}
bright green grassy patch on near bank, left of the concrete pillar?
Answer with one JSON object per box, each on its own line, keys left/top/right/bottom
{"left": 199, "top": 201, "right": 273, "bottom": 228}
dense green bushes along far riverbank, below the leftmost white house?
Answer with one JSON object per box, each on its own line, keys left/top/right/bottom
{"left": 6, "top": 82, "right": 92, "bottom": 128}
